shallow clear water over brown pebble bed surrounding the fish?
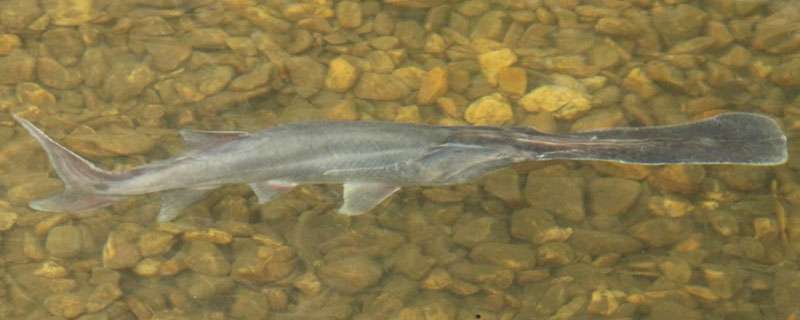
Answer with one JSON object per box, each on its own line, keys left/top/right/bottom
{"left": 0, "top": 0, "right": 800, "bottom": 319}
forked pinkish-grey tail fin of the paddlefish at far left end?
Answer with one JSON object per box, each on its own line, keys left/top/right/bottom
{"left": 12, "top": 115, "right": 121, "bottom": 212}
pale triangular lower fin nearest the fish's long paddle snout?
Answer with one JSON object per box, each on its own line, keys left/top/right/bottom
{"left": 338, "top": 183, "right": 400, "bottom": 216}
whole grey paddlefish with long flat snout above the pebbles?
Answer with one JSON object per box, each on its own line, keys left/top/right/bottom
{"left": 14, "top": 113, "right": 787, "bottom": 221}
